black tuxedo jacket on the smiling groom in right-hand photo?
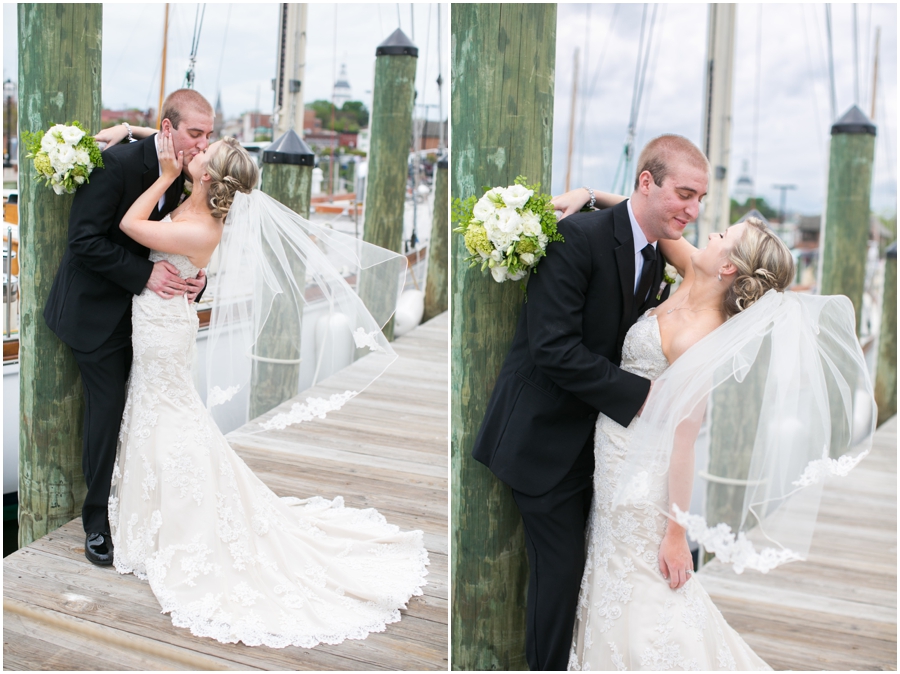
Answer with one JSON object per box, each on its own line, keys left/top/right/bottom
{"left": 472, "top": 201, "right": 669, "bottom": 496}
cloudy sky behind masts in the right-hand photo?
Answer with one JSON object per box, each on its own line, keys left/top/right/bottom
{"left": 553, "top": 3, "right": 897, "bottom": 214}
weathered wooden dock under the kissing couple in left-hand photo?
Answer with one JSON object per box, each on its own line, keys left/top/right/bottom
{"left": 3, "top": 313, "right": 449, "bottom": 671}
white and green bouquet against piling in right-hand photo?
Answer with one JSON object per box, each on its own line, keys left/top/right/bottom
{"left": 452, "top": 176, "right": 563, "bottom": 283}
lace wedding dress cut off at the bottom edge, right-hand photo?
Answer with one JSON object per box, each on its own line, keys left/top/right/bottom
{"left": 569, "top": 314, "right": 771, "bottom": 671}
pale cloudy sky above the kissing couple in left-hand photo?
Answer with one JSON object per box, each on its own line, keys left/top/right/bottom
{"left": 3, "top": 3, "right": 450, "bottom": 124}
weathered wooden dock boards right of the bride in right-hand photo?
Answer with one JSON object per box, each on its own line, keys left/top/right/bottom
{"left": 698, "top": 417, "right": 897, "bottom": 671}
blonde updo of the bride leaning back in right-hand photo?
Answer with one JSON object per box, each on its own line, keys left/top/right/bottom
{"left": 725, "top": 218, "right": 794, "bottom": 318}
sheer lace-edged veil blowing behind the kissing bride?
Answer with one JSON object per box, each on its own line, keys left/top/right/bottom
{"left": 206, "top": 190, "right": 407, "bottom": 432}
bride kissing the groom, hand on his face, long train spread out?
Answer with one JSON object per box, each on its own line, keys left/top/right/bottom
{"left": 109, "top": 135, "right": 428, "bottom": 648}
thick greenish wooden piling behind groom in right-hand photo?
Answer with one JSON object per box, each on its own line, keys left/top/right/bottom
{"left": 450, "top": 4, "right": 556, "bottom": 670}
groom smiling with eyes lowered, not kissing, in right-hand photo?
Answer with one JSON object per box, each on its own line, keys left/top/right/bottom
{"left": 472, "top": 135, "right": 709, "bottom": 670}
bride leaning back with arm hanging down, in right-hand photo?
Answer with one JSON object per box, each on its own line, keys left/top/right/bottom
{"left": 554, "top": 191, "right": 874, "bottom": 670}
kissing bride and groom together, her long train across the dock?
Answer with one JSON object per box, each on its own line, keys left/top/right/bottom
{"left": 44, "top": 89, "right": 428, "bottom": 648}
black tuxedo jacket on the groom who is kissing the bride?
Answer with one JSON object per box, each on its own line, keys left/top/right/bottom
{"left": 44, "top": 136, "right": 184, "bottom": 352}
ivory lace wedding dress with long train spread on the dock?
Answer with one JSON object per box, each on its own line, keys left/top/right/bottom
{"left": 109, "top": 239, "right": 428, "bottom": 648}
